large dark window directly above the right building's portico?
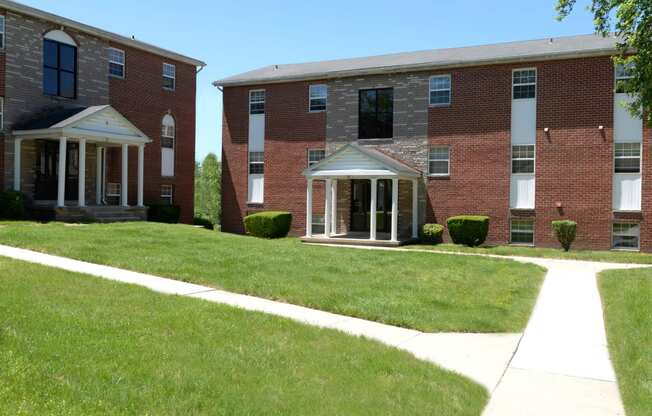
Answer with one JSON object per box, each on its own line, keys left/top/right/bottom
{"left": 358, "top": 88, "right": 394, "bottom": 139}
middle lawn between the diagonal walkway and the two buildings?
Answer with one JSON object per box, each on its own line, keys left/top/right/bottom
{"left": 0, "top": 223, "right": 544, "bottom": 332}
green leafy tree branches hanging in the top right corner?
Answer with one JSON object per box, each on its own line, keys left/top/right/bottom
{"left": 556, "top": 0, "right": 652, "bottom": 123}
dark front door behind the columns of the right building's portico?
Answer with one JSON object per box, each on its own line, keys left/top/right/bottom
{"left": 351, "top": 179, "right": 392, "bottom": 233}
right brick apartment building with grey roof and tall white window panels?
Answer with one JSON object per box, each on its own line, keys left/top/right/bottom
{"left": 215, "top": 35, "right": 652, "bottom": 251}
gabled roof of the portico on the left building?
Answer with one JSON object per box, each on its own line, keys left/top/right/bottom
{"left": 13, "top": 105, "right": 151, "bottom": 145}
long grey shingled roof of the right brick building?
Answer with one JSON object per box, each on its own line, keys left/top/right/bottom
{"left": 214, "top": 35, "right": 618, "bottom": 86}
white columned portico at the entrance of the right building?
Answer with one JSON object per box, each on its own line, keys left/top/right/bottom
{"left": 303, "top": 143, "right": 421, "bottom": 245}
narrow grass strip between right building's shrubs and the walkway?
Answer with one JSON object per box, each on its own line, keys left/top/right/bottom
{"left": 406, "top": 244, "right": 652, "bottom": 264}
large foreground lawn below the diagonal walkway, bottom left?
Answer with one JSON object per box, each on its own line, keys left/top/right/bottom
{"left": 0, "top": 258, "right": 488, "bottom": 416}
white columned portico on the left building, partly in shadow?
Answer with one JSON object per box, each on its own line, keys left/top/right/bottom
{"left": 12, "top": 105, "right": 151, "bottom": 219}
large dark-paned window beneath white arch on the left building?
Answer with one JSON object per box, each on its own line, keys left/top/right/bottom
{"left": 43, "top": 39, "right": 77, "bottom": 98}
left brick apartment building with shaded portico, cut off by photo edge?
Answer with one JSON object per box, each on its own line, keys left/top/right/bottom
{"left": 0, "top": 0, "right": 205, "bottom": 222}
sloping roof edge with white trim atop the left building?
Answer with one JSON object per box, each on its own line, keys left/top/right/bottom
{"left": 0, "top": 0, "right": 206, "bottom": 67}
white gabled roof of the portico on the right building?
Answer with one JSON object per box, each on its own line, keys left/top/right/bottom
{"left": 303, "top": 143, "right": 421, "bottom": 179}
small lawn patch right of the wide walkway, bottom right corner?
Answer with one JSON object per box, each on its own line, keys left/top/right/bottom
{"left": 599, "top": 269, "right": 652, "bottom": 416}
